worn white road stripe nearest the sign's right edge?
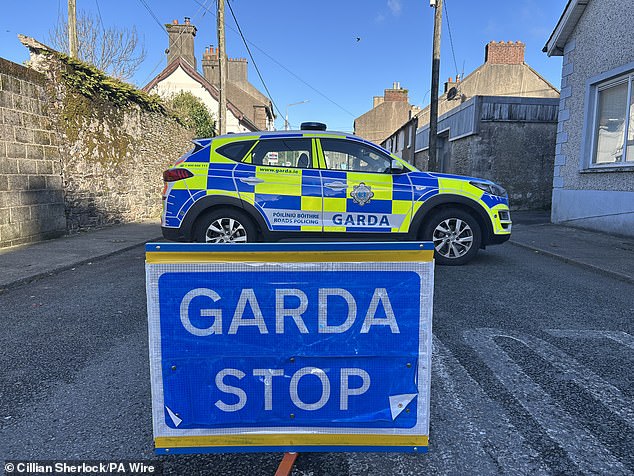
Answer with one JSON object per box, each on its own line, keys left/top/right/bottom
{"left": 428, "top": 336, "right": 551, "bottom": 475}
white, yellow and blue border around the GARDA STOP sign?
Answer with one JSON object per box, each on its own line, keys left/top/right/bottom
{"left": 146, "top": 242, "right": 434, "bottom": 454}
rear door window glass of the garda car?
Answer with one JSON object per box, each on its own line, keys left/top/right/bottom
{"left": 245, "top": 139, "right": 313, "bottom": 169}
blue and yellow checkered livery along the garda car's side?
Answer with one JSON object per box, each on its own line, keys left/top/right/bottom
{"left": 163, "top": 134, "right": 508, "bottom": 234}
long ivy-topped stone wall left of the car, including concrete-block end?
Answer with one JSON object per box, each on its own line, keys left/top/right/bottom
{"left": 0, "top": 37, "right": 193, "bottom": 247}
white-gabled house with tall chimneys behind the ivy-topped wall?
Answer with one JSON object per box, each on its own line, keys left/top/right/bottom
{"left": 143, "top": 18, "right": 275, "bottom": 132}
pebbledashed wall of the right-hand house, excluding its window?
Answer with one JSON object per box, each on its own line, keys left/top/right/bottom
{"left": 552, "top": 0, "right": 634, "bottom": 236}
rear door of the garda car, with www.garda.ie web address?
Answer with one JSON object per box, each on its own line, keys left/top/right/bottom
{"left": 234, "top": 136, "right": 322, "bottom": 232}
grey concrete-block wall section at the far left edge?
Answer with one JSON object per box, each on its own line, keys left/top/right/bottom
{"left": 0, "top": 58, "right": 66, "bottom": 247}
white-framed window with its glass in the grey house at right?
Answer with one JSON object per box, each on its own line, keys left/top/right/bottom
{"left": 592, "top": 75, "right": 634, "bottom": 166}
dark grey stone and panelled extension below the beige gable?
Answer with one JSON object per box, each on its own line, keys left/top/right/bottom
{"left": 414, "top": 96, "right": 558, "bottom": 210}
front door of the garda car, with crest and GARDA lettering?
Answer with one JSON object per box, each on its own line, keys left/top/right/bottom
{"left": 319, "top": 138, "right": 412, "bottom": 233}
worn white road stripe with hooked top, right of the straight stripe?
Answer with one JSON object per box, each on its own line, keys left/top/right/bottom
{"left": 463, "top": 328, "right": 629, "bottom": 474}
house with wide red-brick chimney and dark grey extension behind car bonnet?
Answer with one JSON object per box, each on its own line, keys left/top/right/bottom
{"left": 381, "top": 41, "right": 559, "bottom": 210}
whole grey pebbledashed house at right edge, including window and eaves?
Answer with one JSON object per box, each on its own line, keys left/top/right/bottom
{"left": 544, "top": 0, "right": 634, "bottom": 236}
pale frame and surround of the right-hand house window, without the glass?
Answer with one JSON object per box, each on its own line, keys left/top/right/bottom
{"left": 580, "top": 63, "right": 634, "bottom": 172}
